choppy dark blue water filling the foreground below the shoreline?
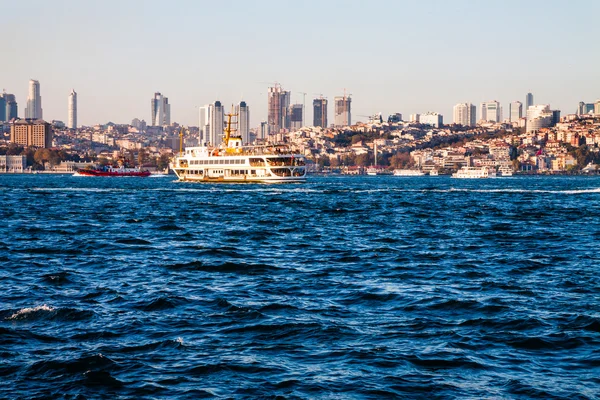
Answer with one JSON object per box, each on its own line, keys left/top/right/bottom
{"left": 0, "top": 175, "right": 600, "bottom": 399}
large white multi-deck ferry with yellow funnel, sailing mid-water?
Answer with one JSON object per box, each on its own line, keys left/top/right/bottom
{"left": 171, "top": 114, "right": 306, "bottom": 183}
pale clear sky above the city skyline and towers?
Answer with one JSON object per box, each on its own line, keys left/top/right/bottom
{"left": 0, "top": 0, "right": 600, "bottom": 127}
